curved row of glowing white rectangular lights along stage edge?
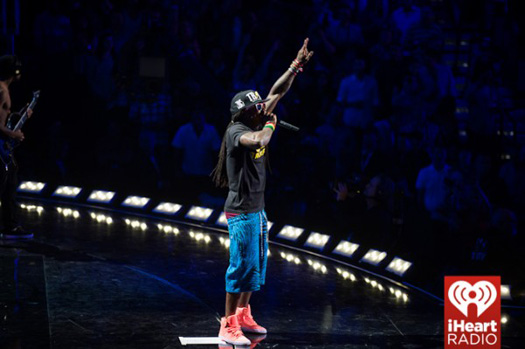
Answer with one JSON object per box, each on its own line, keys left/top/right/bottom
{"left": 18, "top": 181, "right": 412, "bottom": 277}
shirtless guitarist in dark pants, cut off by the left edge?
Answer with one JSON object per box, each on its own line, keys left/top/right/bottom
{"left": 0, "top": 55, "right": 33, "bottom": 239}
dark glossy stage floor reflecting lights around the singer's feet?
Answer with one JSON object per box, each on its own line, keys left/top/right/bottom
{"left": 0, "top": 202, "right": 525, "bottom": 349}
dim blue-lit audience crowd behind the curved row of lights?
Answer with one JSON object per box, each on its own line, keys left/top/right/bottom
{"left": 3, "top": 0, "right": 525, "bottom": 294}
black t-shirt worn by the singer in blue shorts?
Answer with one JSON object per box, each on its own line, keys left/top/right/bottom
{"left": 224, "top": 122, "right": 267, "bottom": 213}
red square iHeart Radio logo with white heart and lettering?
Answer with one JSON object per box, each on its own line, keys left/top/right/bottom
{"left": 444, "top": 276, "right": 501, "bottom": 348}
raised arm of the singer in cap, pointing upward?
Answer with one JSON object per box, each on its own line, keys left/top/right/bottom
{"left": 266, "top": 38, "right": 314, "bottom": 113}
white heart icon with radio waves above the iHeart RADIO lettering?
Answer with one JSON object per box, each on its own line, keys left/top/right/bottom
{"left": 448, "top": 281, "right": 498, "bottom": 317}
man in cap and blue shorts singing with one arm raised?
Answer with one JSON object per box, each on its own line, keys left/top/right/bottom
{"left": 212, "top": 39, "right": 313, "bottom": 345}
